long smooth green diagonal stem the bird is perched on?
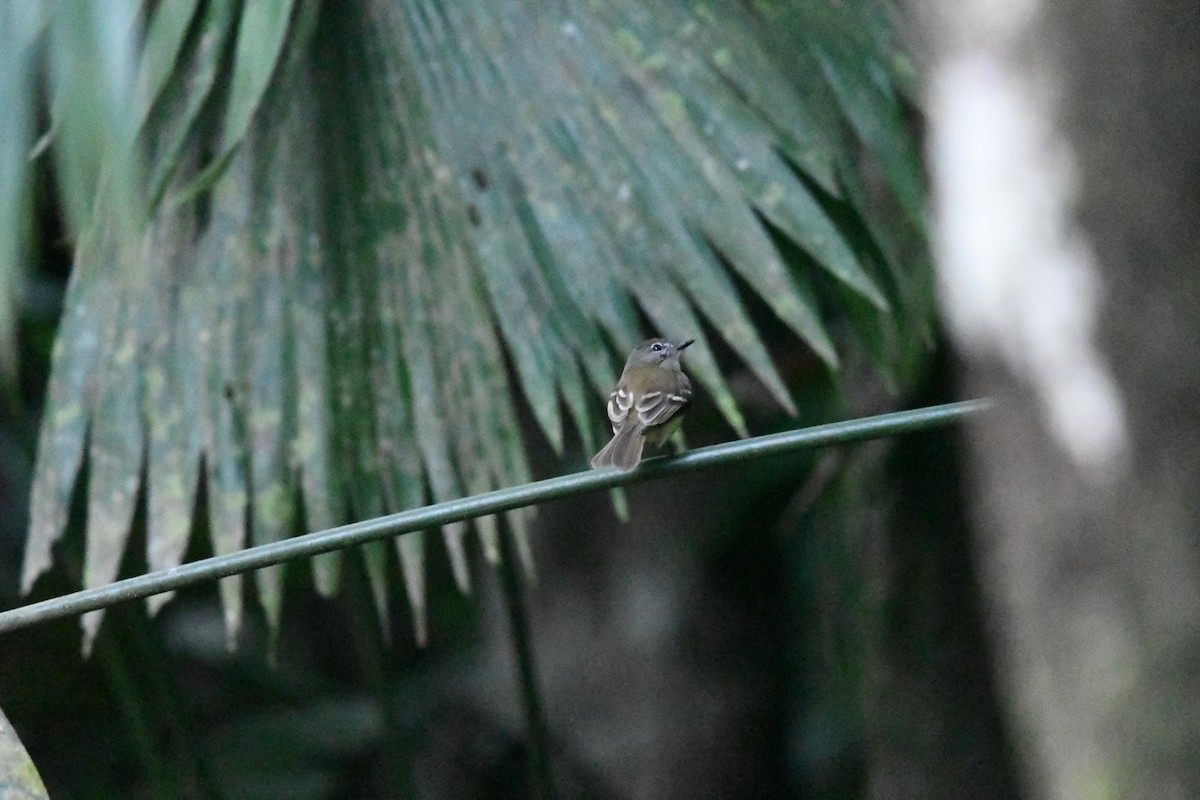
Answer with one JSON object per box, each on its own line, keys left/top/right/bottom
{"left": 0, "top": 399, "right": 992, "bottom": 632}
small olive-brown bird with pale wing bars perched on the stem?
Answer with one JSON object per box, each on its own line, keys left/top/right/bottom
{"left": 592, "top": 339, "right": 695, "bottom": 473}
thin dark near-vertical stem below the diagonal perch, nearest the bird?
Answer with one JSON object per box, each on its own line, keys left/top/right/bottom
{"left": 499, "top": 522, "right": 554, "bottom": 800}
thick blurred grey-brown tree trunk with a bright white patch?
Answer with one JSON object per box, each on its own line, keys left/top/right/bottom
{"left": 914, "top": 0, "right": 1200, "bottom": 799}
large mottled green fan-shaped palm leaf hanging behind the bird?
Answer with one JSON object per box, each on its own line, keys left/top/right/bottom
{"left": 7, "top": 0, "right": 929, "bottom": 636}
